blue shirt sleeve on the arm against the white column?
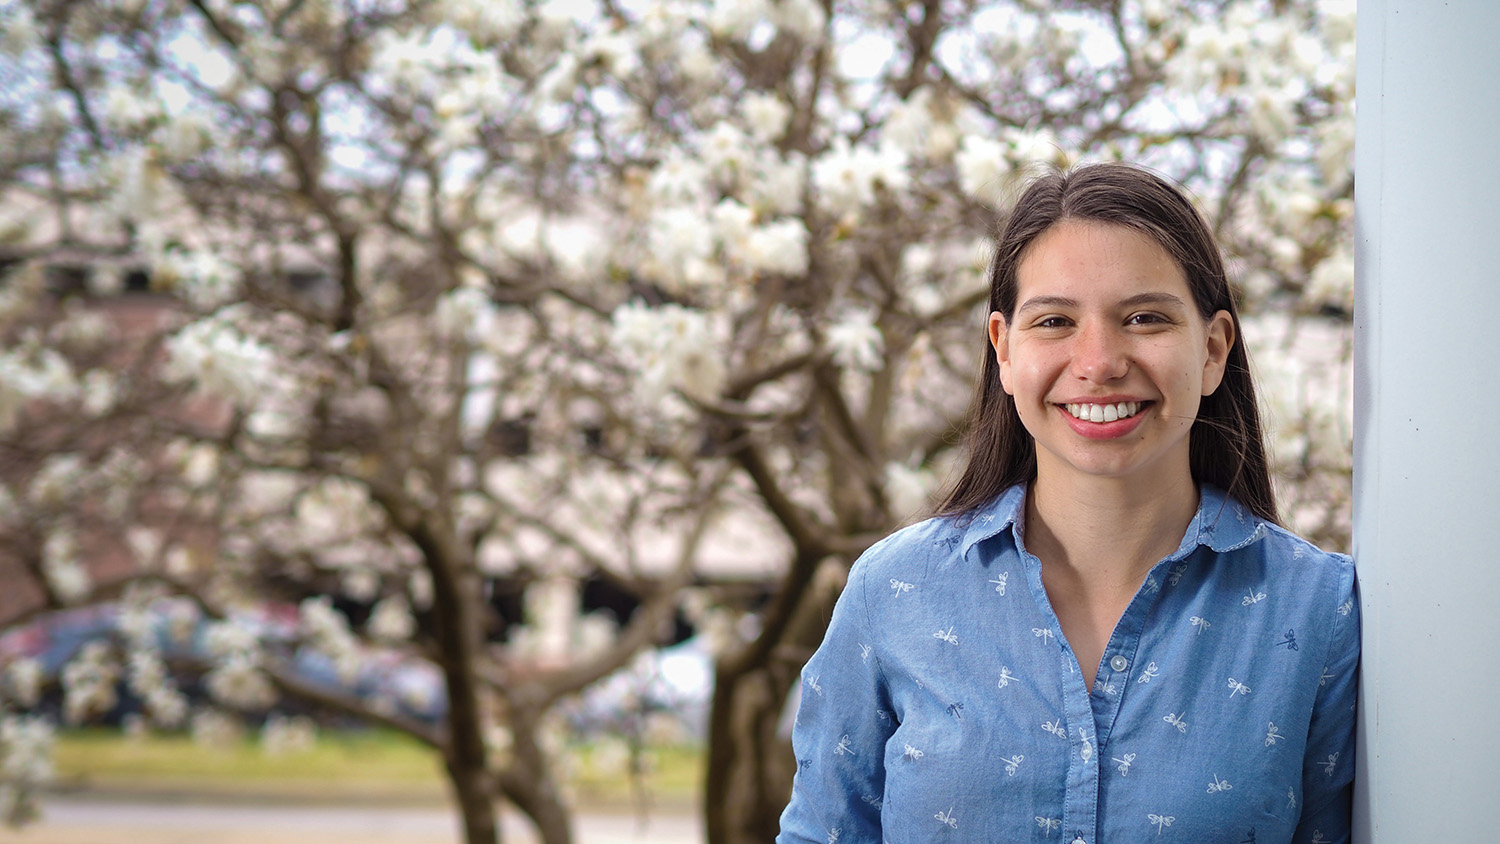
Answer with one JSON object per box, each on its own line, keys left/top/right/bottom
{"left": 1292, "top": 564, "right": 1359, "bottom": 844}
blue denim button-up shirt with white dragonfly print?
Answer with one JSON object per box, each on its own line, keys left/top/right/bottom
{"left": 777, "top": 487, "right": 1359, "bottom": 844}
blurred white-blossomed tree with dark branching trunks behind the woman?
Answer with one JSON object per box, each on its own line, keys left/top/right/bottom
{"left": 0, "top": 0, "right": 1353, "bottom": 844}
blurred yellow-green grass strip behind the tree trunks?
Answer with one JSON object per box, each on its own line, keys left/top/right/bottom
{"left": 56, "top": 730, "right": 704, "bottom": 810}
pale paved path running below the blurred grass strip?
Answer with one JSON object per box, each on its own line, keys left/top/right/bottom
{"left": 23, "top": 798, "right": 704, "bottom": 844}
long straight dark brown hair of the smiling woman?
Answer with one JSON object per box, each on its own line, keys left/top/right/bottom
{"left": 938, "top": 163, "right": 1278, "bottom": 522}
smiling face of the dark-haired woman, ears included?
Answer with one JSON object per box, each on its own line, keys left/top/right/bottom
{"left": 990, "top": 220, "right": 1235, "bottom": 483}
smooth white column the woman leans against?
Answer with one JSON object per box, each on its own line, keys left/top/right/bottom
{"left": 1355, "top": 0, "right": 1500, "bottom": 844}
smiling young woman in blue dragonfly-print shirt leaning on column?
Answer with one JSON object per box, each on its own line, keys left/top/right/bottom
{"left": 777, "top": 165, "right": 1359, "bottom": 844}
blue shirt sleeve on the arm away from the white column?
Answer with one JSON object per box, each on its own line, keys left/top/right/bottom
{"left": 776, "top": 559, "right": 896, "bottom": 844}
